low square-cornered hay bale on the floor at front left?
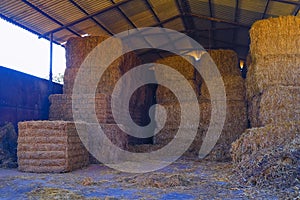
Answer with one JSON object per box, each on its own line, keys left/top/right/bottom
{"left": 17, "top": 121, "right": 89, "bottom": 172}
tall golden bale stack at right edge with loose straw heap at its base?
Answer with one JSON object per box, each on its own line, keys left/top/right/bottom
{"left": 232, "top": 16, "right": 300, "bottom": 187}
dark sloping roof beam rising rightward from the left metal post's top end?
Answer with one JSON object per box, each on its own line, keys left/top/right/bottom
{"left": 40, "top": 0, "right": 132, "bottom": 37}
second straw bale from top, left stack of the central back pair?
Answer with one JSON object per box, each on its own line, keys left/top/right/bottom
{"left": 156, "top": 80, "right": 200, "bottom": 103}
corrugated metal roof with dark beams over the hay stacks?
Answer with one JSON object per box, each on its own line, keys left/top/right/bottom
{"left": 0, "top": 0, "right": 300, "bottom": 58}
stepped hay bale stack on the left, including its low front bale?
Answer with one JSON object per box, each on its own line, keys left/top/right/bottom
{"left": 18, "top": 36, "right": 151, "bottom": 172}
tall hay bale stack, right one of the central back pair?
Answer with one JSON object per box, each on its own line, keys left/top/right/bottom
{"left": 198, "top": 50, "right": 248, "bottom": 161}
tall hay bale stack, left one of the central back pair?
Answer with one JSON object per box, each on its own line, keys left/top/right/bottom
{"left": 154, "top": 56, "right": 201, "bottom": 150}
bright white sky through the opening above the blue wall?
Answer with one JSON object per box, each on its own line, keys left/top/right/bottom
{"left": 0, "top": 19, "right": 66, "bottom": 79}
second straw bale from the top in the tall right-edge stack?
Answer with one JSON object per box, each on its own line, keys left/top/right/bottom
{"left": 246, "top": 54, "right": 300, "bottom": 99}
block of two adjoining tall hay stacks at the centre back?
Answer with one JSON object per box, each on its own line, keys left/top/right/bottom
{"left": 155, "top": 50, "right": 248, "bottom": 161}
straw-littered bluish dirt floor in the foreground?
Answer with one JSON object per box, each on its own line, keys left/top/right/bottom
{"left": 0, "top": 159, "right": 297, "bottom": 200}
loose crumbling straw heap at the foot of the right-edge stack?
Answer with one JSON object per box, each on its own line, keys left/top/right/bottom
{"left": 231, "top": 121, "right": 300, "bottom": 189}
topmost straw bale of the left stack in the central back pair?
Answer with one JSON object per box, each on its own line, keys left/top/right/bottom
{"left": 154, "top": 56, "right": 201, "bottom": 81}
